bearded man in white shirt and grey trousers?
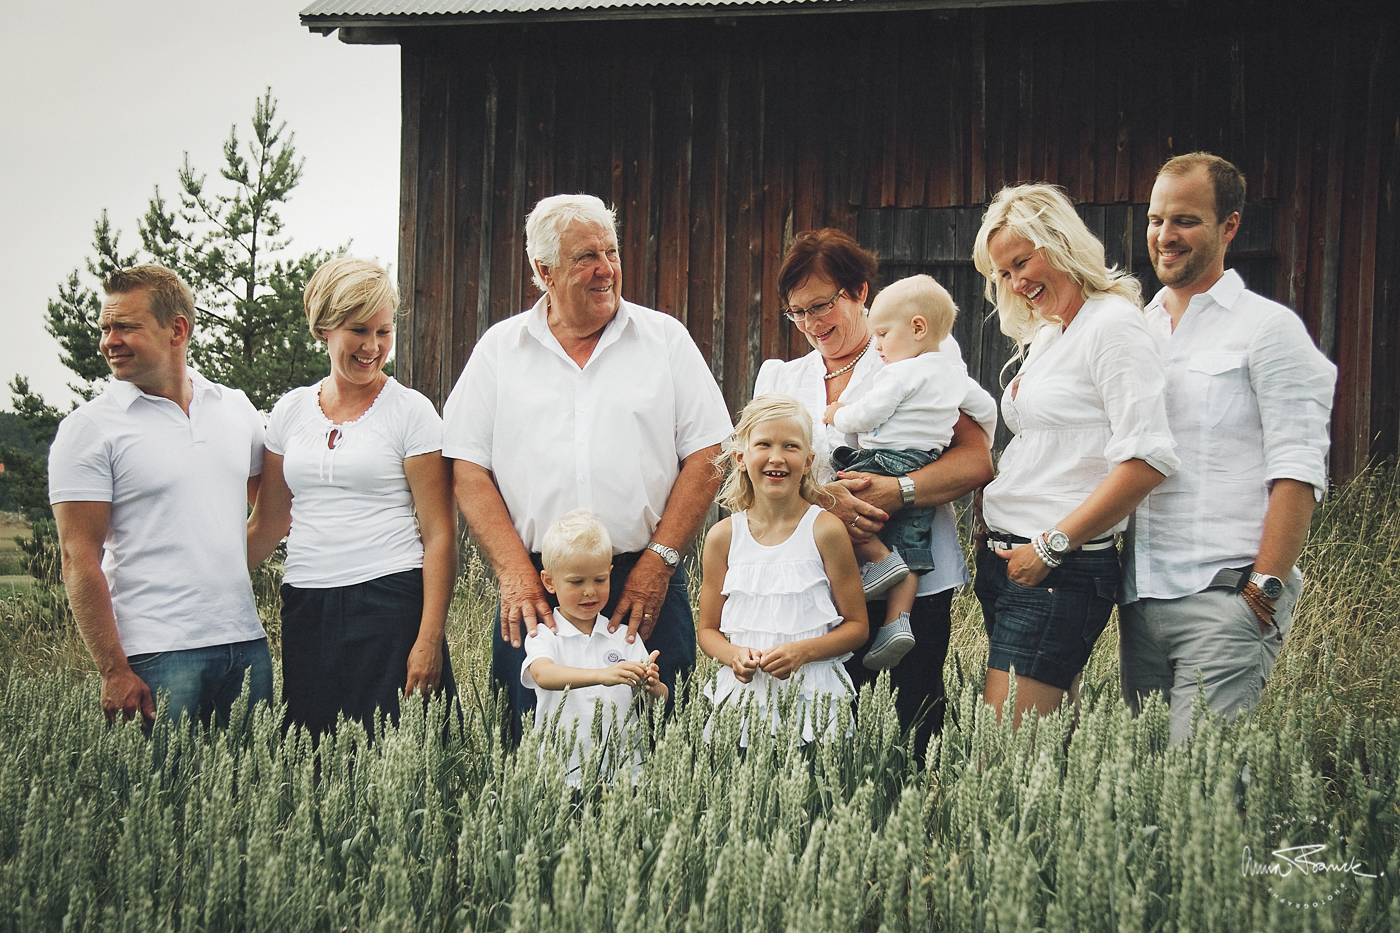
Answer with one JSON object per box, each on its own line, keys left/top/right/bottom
{"left": 1120, "top": 153, "right": 1337, "bottom": 742}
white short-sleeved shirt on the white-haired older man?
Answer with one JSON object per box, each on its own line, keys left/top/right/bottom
{"left": 442, "top": 298, "right": 734, "bottom": 553}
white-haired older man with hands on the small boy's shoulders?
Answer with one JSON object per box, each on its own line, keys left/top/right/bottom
{"left": 442, "top": 195, "right": 732, "bottom": 737}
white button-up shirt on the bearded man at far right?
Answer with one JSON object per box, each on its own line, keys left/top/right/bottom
{"left": 1123, "top": 270, "right": 1337, "bottom": 602}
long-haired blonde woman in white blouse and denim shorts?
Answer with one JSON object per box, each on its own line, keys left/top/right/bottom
{"left": 973, "top": 185, "right": 1179, "bottom": 723}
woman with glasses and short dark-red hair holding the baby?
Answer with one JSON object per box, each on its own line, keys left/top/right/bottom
{"left": 753, "top": 230, "right": 997, "bottom": 758}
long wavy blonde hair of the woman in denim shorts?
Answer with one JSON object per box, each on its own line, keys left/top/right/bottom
{"left": 972, "top": 185, "right": 1142, "bottom": 350}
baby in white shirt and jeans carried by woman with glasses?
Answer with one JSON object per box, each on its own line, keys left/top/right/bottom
{"left": 823, "top": 276, "right": 967, "bottom": 671}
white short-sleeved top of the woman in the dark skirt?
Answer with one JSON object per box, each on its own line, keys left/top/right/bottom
{"left": 267, "top": 377, "right": 442, "bottom": 588}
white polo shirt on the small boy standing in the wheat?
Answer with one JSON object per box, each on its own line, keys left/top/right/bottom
{"left": 521, "top": 609, "right": 648, "bottom": 772}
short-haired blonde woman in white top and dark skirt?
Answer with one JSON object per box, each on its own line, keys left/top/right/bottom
{"left": 248, "top": 256, "right": 456, "bottom": 735}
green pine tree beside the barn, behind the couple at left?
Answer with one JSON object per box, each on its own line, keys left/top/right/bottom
{"left": 6, "top": 88, "right": 333, "bottom": 546}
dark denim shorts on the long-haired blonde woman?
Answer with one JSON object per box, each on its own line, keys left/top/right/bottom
{"left": 976, "top": 537, "right": 1119, "bottom": 691}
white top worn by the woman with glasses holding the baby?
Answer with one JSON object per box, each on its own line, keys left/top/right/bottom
{"left": 753, "top": 338, "right": 997, "bottom": 595}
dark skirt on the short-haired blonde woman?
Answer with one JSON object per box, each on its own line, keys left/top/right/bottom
{"left": 281, "top": 569, "right": 456, "bottom": 735}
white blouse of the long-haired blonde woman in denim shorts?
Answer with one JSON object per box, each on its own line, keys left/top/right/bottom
{"left": 981, "top": 296, "right": 1179, "bottom": 538}
